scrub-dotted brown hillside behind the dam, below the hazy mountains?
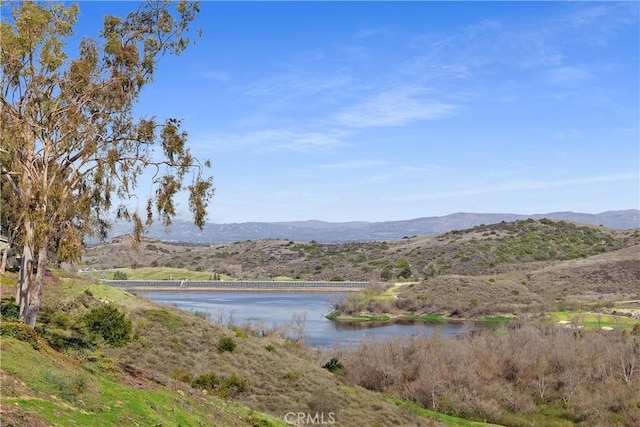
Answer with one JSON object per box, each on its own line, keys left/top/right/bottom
{"left": 80, "top": 219, "right": 640, "bottom": 281}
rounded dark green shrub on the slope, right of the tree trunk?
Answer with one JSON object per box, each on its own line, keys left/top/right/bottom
{"left": 82, "top": 305, "right": 132, "bottom": 347}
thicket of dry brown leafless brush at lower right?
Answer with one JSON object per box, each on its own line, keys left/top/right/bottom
{"left": 337, "top": 322, "right": 640, "bottom": 426}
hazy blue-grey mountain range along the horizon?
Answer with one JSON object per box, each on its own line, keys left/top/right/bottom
{"left": 110, "top": 209, "right": 640, "bottom": 245}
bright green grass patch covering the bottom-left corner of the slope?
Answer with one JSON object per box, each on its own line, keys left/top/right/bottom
{"left": 1, "top": 338, "right": 286, "bottom": 426}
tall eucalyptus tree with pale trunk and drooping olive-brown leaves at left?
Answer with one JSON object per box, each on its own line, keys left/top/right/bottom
{"left": 0, "top": 1, "right": 214, "bottom": 326}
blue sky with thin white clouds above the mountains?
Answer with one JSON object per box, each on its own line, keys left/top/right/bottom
{"left": 75, "top": 1, "right": 640, "bottom": 223}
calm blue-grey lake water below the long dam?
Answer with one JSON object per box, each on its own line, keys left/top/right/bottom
{"left": 139, "top": 291, "right": 479, "bottom": 347}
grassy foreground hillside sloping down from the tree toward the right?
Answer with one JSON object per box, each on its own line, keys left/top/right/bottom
{"left": 0, "top": 271, "right": 496, "bottom": 427}
